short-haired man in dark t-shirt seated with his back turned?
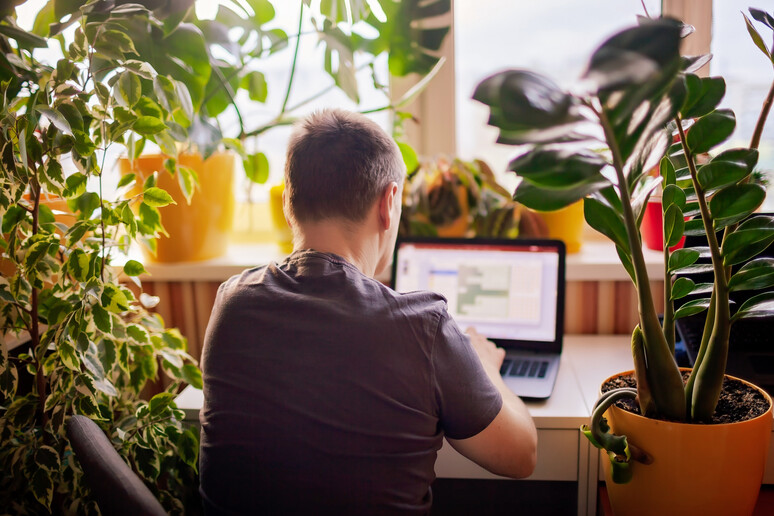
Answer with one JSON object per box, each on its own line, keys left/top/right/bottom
{"left": 200, "top": 110, "right": 537, "bottom": 514}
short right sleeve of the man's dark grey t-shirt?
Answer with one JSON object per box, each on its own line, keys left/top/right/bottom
{"left": 432, "top": 310, "right": 503, "bottom": 439}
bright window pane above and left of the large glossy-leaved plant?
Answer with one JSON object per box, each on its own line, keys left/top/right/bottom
{"left": 454, "top": 0, "right": 661, "bottom": 188}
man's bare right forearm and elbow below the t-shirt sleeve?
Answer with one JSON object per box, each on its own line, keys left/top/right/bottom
{"left": 447, "top": 329, "right": 537, "bottom": 478}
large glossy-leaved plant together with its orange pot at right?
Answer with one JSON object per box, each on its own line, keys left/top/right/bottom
{"left": 474, "top": 9, "right": 774, "bottom": 514}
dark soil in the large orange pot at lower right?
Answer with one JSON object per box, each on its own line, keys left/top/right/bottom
{"left": 602, "top": 371, "right": 769, "bottom": 424}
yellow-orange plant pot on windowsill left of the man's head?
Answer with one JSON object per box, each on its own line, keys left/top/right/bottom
{"left": 120, "top": 152, "right": 235, "bottom": 263}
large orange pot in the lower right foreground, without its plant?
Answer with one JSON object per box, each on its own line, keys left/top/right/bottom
{"left": 601, "top": 371, "right": 772, "bottom": 516}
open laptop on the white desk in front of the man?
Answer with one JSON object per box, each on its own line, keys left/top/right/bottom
{"left": 392, "top": 237, "right": 566, "bottom": 398}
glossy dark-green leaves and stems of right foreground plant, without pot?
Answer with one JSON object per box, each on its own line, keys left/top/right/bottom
{"left": 474, "top": 9, "right": 774, "bottom": 481}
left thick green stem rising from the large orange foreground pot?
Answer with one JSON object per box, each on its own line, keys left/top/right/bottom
{"left": 597, "top": 106, "right": 685, "bottom": 421}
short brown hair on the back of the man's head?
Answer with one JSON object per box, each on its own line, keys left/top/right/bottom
{"left": 285, "top": 109, "right": 406, "bottom": 222}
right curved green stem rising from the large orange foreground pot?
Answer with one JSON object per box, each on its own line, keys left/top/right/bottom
{"left": 676, "top": 116, "right": 731, "bottom": 421}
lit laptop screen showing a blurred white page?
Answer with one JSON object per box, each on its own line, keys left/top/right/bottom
{"left": 394, "top": 242, "right": 559, "bottom": 342}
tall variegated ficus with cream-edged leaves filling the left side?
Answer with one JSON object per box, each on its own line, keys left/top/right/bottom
{"left": 0, "top": 0, "right": 201, "bottom": 514}
